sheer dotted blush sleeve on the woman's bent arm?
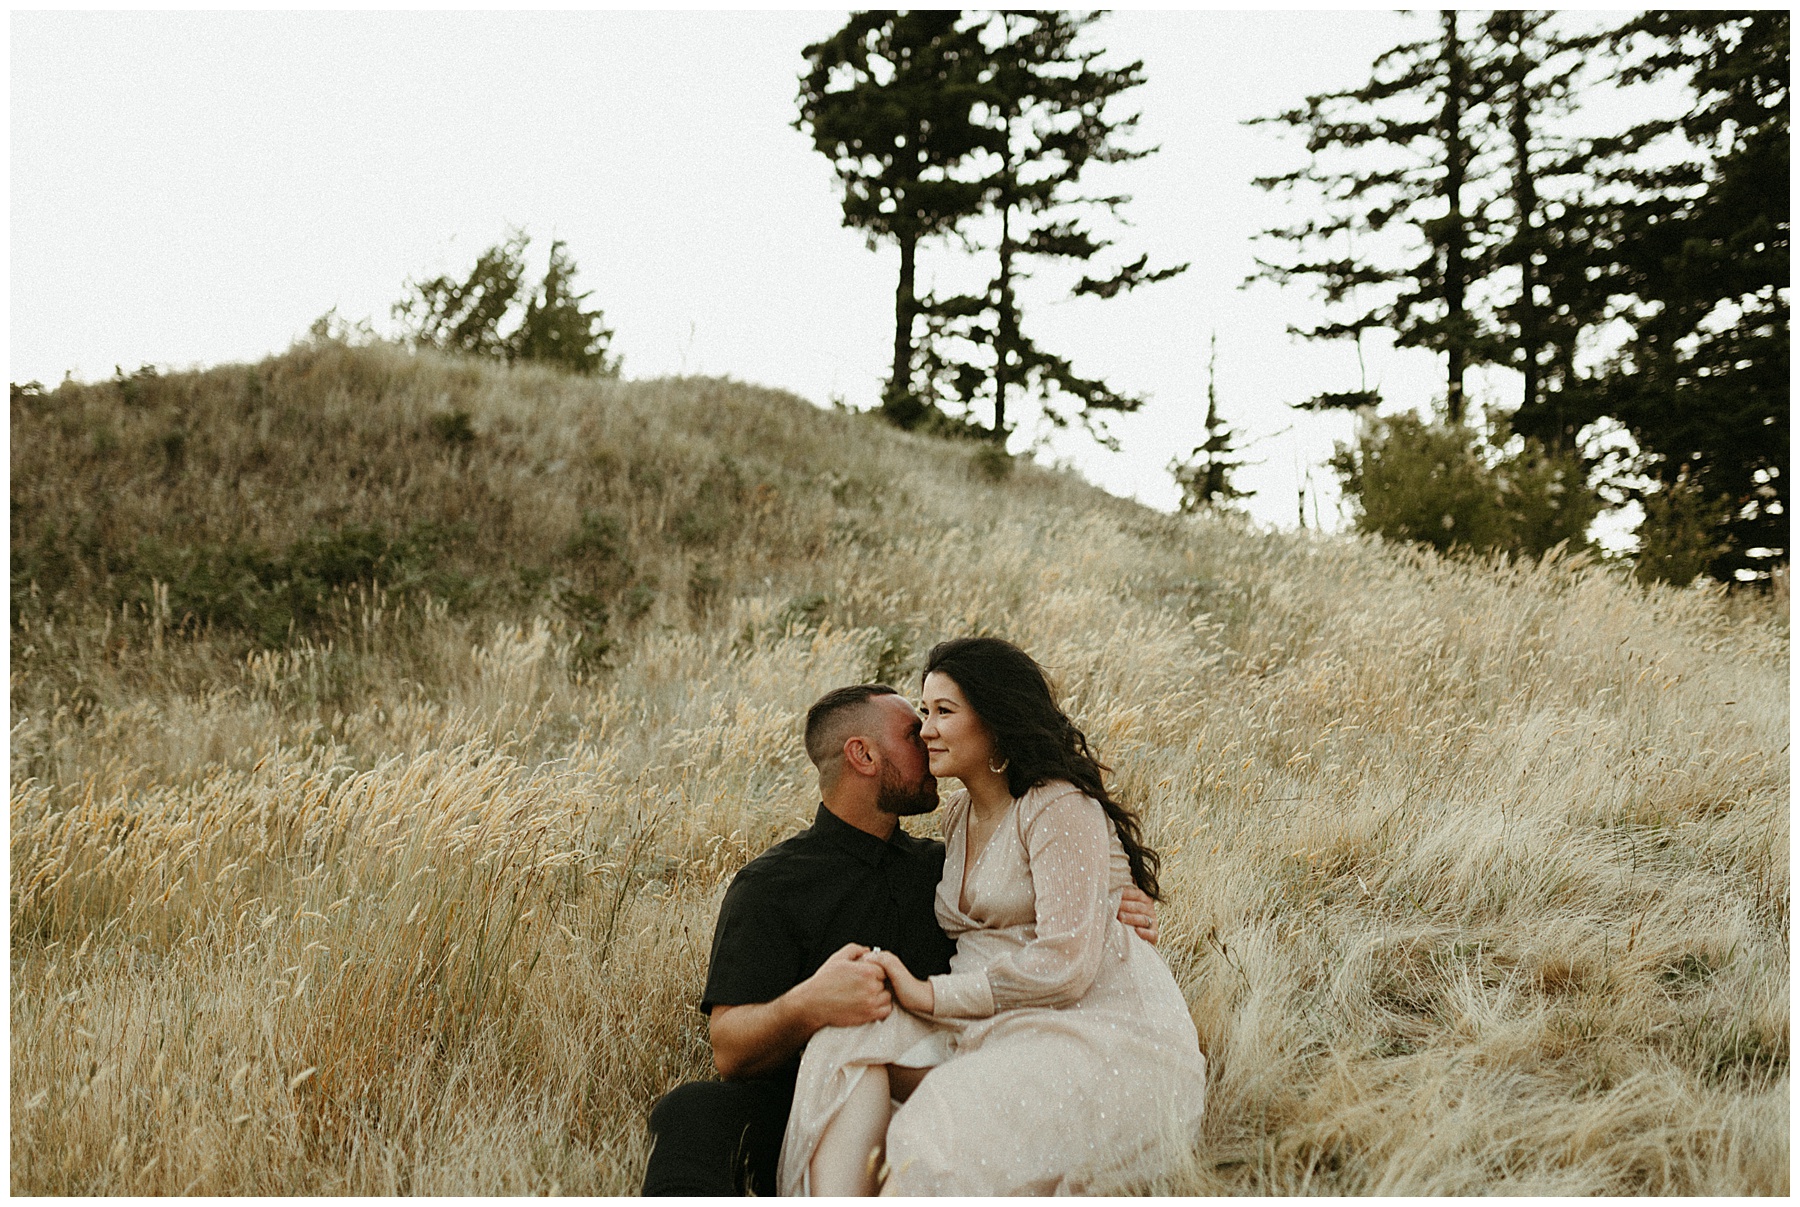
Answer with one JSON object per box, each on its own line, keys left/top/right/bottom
{"left": 931, "top": 784, "right": 1116, "bottom": 1018}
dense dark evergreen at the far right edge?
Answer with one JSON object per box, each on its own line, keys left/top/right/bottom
{"left": 1589, "top": 9, "right": 1789, "bottom": 581}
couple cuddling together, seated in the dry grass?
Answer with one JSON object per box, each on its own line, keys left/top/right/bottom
{"left": 644, "top": 637, "right": 1206, "bottom": 1194}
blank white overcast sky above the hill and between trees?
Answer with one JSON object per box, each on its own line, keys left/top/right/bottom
{"left": 9, "top": 11, "right": 1648, "bottom": 527}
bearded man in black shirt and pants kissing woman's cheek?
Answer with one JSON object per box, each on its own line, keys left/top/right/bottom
{"left": 643, "top": 684, "right": 1156, "bottom": 1194}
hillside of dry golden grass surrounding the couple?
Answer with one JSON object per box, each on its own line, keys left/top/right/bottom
{"left": 11, "top": 344, "right": 1789, "bottom": 1194}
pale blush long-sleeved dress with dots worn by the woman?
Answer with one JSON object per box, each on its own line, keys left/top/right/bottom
{"left": 778, "top": 781, "right": 1206, "bottom": 1194}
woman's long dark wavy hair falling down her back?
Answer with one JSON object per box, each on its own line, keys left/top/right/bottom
{"left": 925, "top": 637, "right": 1163, "bottom": 901}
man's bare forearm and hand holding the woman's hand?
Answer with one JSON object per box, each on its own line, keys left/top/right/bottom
{"left": 707, "top": 943, "right": 893, "bottom": 1077}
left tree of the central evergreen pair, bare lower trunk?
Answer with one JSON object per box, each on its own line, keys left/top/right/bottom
{"left": 796, "top": 9, "right": 995, "bottom": 428}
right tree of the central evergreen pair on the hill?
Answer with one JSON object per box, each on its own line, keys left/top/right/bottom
{"left": 927, "top": 11, "right": 1186, "bottom": 443}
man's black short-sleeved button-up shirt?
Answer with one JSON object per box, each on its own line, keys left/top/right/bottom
{"left": 700, "top": 804, "right": 956, "bottom": 1077}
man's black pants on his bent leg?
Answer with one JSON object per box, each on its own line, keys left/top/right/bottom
{"left": 643, "top": 1079, "right": 794, "bottom": 1196}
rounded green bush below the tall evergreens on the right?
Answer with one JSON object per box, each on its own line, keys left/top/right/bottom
{"left": 1330, "top": 414, "right": 1600, "bottom": 558}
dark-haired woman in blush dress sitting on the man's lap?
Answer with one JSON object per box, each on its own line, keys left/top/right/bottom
{"left": 779, "top": 637, "right": 1206, "bottom": 1194}
